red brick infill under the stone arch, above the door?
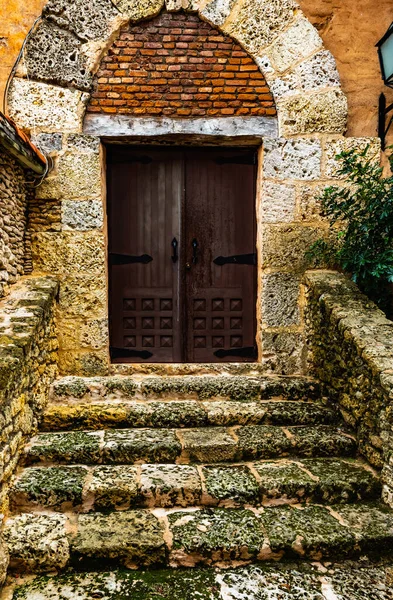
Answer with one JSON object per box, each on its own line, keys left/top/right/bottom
{"left": 87, "top": 12, "right": 276, "bottom": 117}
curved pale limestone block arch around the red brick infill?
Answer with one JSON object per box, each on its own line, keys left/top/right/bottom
{"left": 8, "top": 0, "right": 347, "bottom": 137}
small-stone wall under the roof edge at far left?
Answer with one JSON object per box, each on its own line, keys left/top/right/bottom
{"left": 0, "top": 150, "right": 29, "bottom": 297}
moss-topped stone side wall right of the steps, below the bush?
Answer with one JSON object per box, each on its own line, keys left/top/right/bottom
{"left": 305, "top": 271, "right": 393, "bottom": 507}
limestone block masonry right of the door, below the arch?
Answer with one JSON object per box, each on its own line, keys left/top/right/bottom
{"left": 258, "top": 136, "right": 380, "bottom": 374}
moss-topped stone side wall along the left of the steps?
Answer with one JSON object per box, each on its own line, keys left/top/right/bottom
{"left": 0, "top": 277, "right": 58, "bottom": 513}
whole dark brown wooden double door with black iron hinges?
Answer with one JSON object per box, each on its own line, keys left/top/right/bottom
{"left": 107, "top": 146, "right": 257, "bottom": 363}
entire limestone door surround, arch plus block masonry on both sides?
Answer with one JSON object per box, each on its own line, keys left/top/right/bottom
{"left": 3, "top": 0, "right": 379, "bottom": 375}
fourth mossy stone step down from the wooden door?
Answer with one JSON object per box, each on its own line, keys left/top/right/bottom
{"left": 10, "top": 458, "right": 381, "bottom": 512}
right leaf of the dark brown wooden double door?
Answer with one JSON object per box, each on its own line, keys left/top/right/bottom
{"left": 185, "top": 149, "right": 256, "bottom": 362}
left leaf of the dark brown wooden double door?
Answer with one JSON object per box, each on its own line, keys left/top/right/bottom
{"left": 108, "top": 148, "right": 184, "bottom": 362}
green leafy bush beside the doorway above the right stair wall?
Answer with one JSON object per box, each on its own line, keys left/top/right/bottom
{"left": 307, "top": 147, "right": 393, "bottom": 309}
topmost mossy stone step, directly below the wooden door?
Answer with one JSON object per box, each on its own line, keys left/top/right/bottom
{"left": 50, "top": 374, "right": 321, "bottom": 402}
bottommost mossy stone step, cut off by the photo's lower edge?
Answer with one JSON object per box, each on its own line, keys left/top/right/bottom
{"left": 4, "top": 561, "right": 393, "bottom": 600}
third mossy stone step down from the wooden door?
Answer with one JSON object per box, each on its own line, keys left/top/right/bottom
{"left": 22, "top": 425, "right": 356, "bottom": 465}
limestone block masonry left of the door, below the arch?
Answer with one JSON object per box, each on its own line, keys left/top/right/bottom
{"left": 29, "top": 134, "right": 109, "bottom": 375}
